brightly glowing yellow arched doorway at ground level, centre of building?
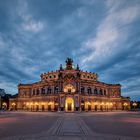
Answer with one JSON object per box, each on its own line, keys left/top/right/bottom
{"left": 65, "top": 97, "right": 74, "bottom": 112}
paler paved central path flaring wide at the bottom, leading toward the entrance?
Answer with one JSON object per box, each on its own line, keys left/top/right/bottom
{"left": 1, "top": 113, "right": 138, "bottom": 140}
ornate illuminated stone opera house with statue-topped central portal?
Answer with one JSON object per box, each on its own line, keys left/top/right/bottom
{"left": 10, "top": 58, "right": 130, "bottom": 112}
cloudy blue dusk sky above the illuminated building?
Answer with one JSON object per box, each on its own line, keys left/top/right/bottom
{"left": 0, "top": 0, "right": 140, "bottom": 100}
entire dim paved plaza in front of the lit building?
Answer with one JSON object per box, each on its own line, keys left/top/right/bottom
{"left": 0, "top": 112, "right": 140, "bottom": 140}
